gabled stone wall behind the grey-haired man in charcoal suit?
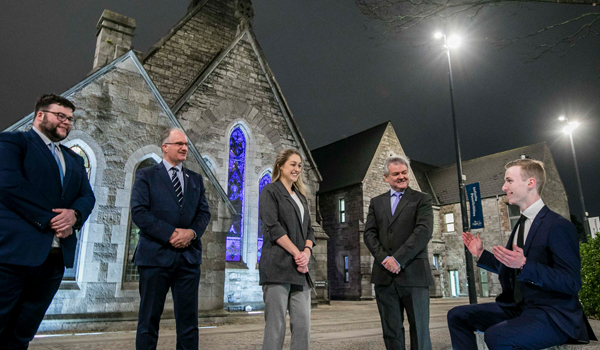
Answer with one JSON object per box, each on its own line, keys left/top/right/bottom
{"left": 319, "top": 123, "right": 445, "bottom": 299}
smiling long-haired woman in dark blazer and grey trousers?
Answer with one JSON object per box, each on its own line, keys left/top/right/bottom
{"left": 259, "top": 149, "right": 315, "bottom": 350}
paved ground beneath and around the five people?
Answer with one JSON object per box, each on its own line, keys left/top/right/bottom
{"left": 29, "top": 298, "right": 600, "bottom": 350}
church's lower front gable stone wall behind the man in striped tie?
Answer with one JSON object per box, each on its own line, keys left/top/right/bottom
{"left": 12, "top": 57, "right": 229, "bottom": 329}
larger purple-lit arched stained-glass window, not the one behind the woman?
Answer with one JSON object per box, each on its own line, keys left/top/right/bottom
{"left": 225, "top": 127, "right": 246, "bottom": 261}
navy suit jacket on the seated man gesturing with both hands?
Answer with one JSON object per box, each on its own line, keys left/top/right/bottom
{"left": 477, "top": 206, "right": 595, "bottom": 341}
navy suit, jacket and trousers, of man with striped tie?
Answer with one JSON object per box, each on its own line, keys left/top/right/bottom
{"left": 131, "top": 162, "right": 210, "bottom": 349}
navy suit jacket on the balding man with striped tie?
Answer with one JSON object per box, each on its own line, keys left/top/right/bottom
{"left": 131, "top": 162, "right": 210, "bottom": 267}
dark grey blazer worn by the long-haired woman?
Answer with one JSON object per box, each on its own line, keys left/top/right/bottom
{"left": 259, "top": 181, "right": 315, "bottom": 285}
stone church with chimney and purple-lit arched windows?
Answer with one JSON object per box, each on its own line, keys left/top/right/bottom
{"left": 7, "top": 0, "right": 328, "bottom": 330}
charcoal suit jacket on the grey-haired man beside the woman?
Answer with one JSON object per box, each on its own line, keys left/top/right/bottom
{"left": 364, "top": 187, "right": 433, "bottom": 287}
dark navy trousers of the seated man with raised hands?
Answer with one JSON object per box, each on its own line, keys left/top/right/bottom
{"left": 448, "top": 303, "right": 569, "bottom": 350}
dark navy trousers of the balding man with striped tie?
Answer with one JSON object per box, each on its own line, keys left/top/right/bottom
{"left": 135, "top": 253, "right": 200, "bottom": 350}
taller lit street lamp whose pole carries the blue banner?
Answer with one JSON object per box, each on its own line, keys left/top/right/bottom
{"left": 435, "top": 32, "right": 477, "bottom": 304}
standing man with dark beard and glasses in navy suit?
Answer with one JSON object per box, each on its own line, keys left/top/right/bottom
{"left": 0, "top": 95, "right": 95, "bottom": 350}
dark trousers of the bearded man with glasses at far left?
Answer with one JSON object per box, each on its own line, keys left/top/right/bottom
{"left": 0, "top": 250, "right": 65, "bottom": 350}
